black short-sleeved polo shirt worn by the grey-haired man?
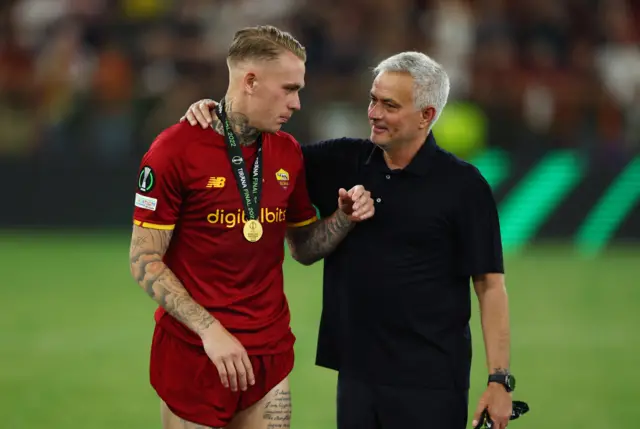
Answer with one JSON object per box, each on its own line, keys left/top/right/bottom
{"left": 303, "top": 134, "right": 503, "bottom": 389}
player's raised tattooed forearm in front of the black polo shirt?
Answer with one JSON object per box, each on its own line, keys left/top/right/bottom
{"left": 287, "top": 210, "right": 354, "bottom": 265}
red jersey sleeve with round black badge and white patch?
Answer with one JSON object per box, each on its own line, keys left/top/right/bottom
{"left": 133, "top": 135, "right": 182, "bottom": 230}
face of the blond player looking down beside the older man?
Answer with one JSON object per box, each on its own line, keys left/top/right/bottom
{"left": 249, "top": 51, "right": 305, "bottom": 133}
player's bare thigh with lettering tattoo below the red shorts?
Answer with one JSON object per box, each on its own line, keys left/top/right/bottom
{"left": 225, "top": 377, "right": 291, "bottom": 429}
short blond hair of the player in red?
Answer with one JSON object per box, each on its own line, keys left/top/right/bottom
{"left": 227, "top": 25, "right": 307, "bottom": 64}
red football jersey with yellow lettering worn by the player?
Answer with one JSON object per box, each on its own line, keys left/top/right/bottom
{"left": 134, "top": 123, "right": 316, "bottom": 354}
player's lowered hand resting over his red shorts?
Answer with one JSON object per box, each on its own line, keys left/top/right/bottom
{"left": 202, "top": 320, "right": 256, "bottom": 392}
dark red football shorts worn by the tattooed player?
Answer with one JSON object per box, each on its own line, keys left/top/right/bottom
{"left": 150, "top": 325, "right": 294, "bottom": 427}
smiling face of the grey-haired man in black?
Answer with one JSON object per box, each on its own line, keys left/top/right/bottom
{"left": 369, "top": 72, "right": 424, "bottom": 147}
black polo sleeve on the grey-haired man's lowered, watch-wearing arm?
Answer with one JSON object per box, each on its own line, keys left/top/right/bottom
{"left": 456, "top": 170, "right": 504, "bottom": 276}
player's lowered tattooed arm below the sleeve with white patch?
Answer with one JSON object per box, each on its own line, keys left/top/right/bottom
{"left": 129, "top": 226, "right": 215, "bottom": 335}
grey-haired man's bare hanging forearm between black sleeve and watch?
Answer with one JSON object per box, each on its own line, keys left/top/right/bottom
{"left": 473, "top": 273, "right": 511, "bottom": 374}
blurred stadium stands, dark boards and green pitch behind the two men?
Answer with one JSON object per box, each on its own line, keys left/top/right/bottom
{"left": 0, "top": 0, "right": 640, "bottom": 429}
